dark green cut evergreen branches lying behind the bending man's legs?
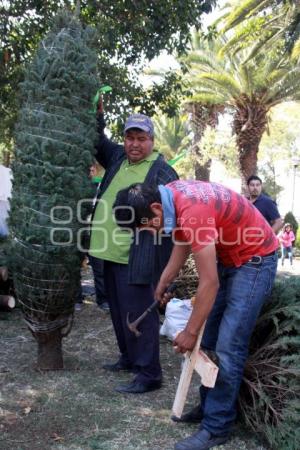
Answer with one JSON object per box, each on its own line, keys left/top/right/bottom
{"left": 239, "top": 277, "right": 300, "bottom": 450}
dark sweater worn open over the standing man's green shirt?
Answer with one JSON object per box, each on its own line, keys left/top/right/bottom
{"left": 96, "top": 115, "right": 178, "bottom": 284}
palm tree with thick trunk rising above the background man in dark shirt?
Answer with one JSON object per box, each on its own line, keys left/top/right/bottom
{"left": 184, "top": 33, "right": 300, "bottom": 186}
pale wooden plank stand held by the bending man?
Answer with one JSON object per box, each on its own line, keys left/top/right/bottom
{"left": 172, "top": 324, "right": 219, "bottom": 418}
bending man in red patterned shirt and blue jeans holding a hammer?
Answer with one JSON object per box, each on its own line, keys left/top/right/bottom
{"left": 115, "top": 181, "right": 278, "bottom": 450}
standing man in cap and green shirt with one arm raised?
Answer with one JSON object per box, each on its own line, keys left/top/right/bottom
{"left": 89, "top": 111, "right": 178, "bottom": 394}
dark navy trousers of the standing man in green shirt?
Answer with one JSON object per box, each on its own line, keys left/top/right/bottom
{"left": 104, "top": 261, "right": 162, "bottom": 382}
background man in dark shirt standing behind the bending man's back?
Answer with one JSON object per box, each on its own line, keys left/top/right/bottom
{"left": 247, "top": 175, "right": 283, "bottom": 234}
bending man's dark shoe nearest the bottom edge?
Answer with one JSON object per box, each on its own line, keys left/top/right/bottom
{"left": 174, "top": 428, "right": 228, "bottom": 450}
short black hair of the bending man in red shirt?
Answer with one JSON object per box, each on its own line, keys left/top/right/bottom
{"left": 113, "top": 183, "right": 161, "bottom": 229}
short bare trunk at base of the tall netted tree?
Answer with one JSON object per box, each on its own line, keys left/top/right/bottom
{"left": 33, "top": 329, "right": 64, "bottom": 370}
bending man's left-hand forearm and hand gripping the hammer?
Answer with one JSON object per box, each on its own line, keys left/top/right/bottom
{"left": 154, "top": 244, "right": 190, "bottom": 301}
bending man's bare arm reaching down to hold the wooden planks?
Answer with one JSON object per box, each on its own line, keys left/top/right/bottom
{"left": 173, "top": 244, "right": 219, "bottom": 353}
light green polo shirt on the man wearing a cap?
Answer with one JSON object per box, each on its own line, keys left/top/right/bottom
{"left": 89, "top": 150, "right": 158, "bottom": 264}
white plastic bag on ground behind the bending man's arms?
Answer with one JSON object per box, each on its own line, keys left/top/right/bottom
{"left": 160, "top": 298, "right": 193, "bottom": 340}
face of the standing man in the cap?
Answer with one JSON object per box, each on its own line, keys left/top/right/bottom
{"left": 124, "top": 128, "right": 154, "bottom": 163}
